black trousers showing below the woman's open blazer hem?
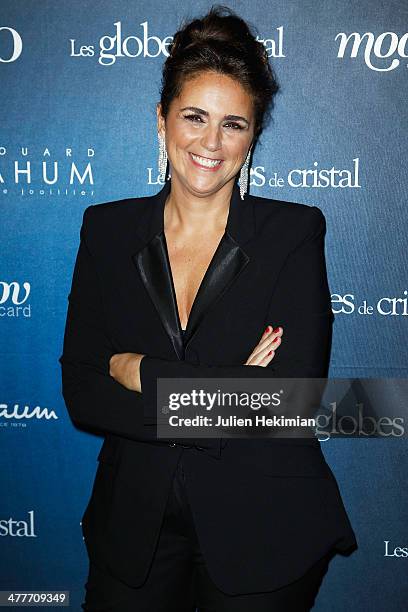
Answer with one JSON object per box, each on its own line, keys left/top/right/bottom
{"left": 81, "top": 450, "right": 331, "bottom": 612}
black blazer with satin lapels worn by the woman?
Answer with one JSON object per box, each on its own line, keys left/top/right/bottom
{"left": 60, "top": 176, "right": 356, "bottom": 594}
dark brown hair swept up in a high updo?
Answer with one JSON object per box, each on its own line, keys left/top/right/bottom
{"left": 160, "top": 5, "right": 279, "bottom": 140}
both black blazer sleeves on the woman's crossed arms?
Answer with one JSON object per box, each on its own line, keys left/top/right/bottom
{"left": 59, "top": 206, "right": 333, "bottom": 440}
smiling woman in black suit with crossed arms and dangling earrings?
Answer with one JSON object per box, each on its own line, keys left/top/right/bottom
{"left": 60, "top": 7, "right": 356, "bottom": 612}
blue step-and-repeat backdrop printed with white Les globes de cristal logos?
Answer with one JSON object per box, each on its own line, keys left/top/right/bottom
{"left": 0, "top": 0, "right": 408, "bottom": 612}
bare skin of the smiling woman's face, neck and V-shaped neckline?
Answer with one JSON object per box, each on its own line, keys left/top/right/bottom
{"left": 153, "top": 66, "right": 274, "bottom": 338}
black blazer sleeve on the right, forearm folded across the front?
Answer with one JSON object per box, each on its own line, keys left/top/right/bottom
{"left": 140, "top": 206, "right": 334, "bottom": 412}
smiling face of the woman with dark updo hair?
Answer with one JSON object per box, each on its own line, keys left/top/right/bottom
{"left": 157, "top": 72, "right": 254, "bottom": 196}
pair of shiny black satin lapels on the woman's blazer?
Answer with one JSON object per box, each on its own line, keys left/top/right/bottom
{"left": 132, "top": 181, "right": 255, "bottom": 359}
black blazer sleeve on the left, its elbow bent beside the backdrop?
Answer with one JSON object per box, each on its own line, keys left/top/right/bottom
{"left": 59, "top": 206, "right": 156, "bottom": 439}
